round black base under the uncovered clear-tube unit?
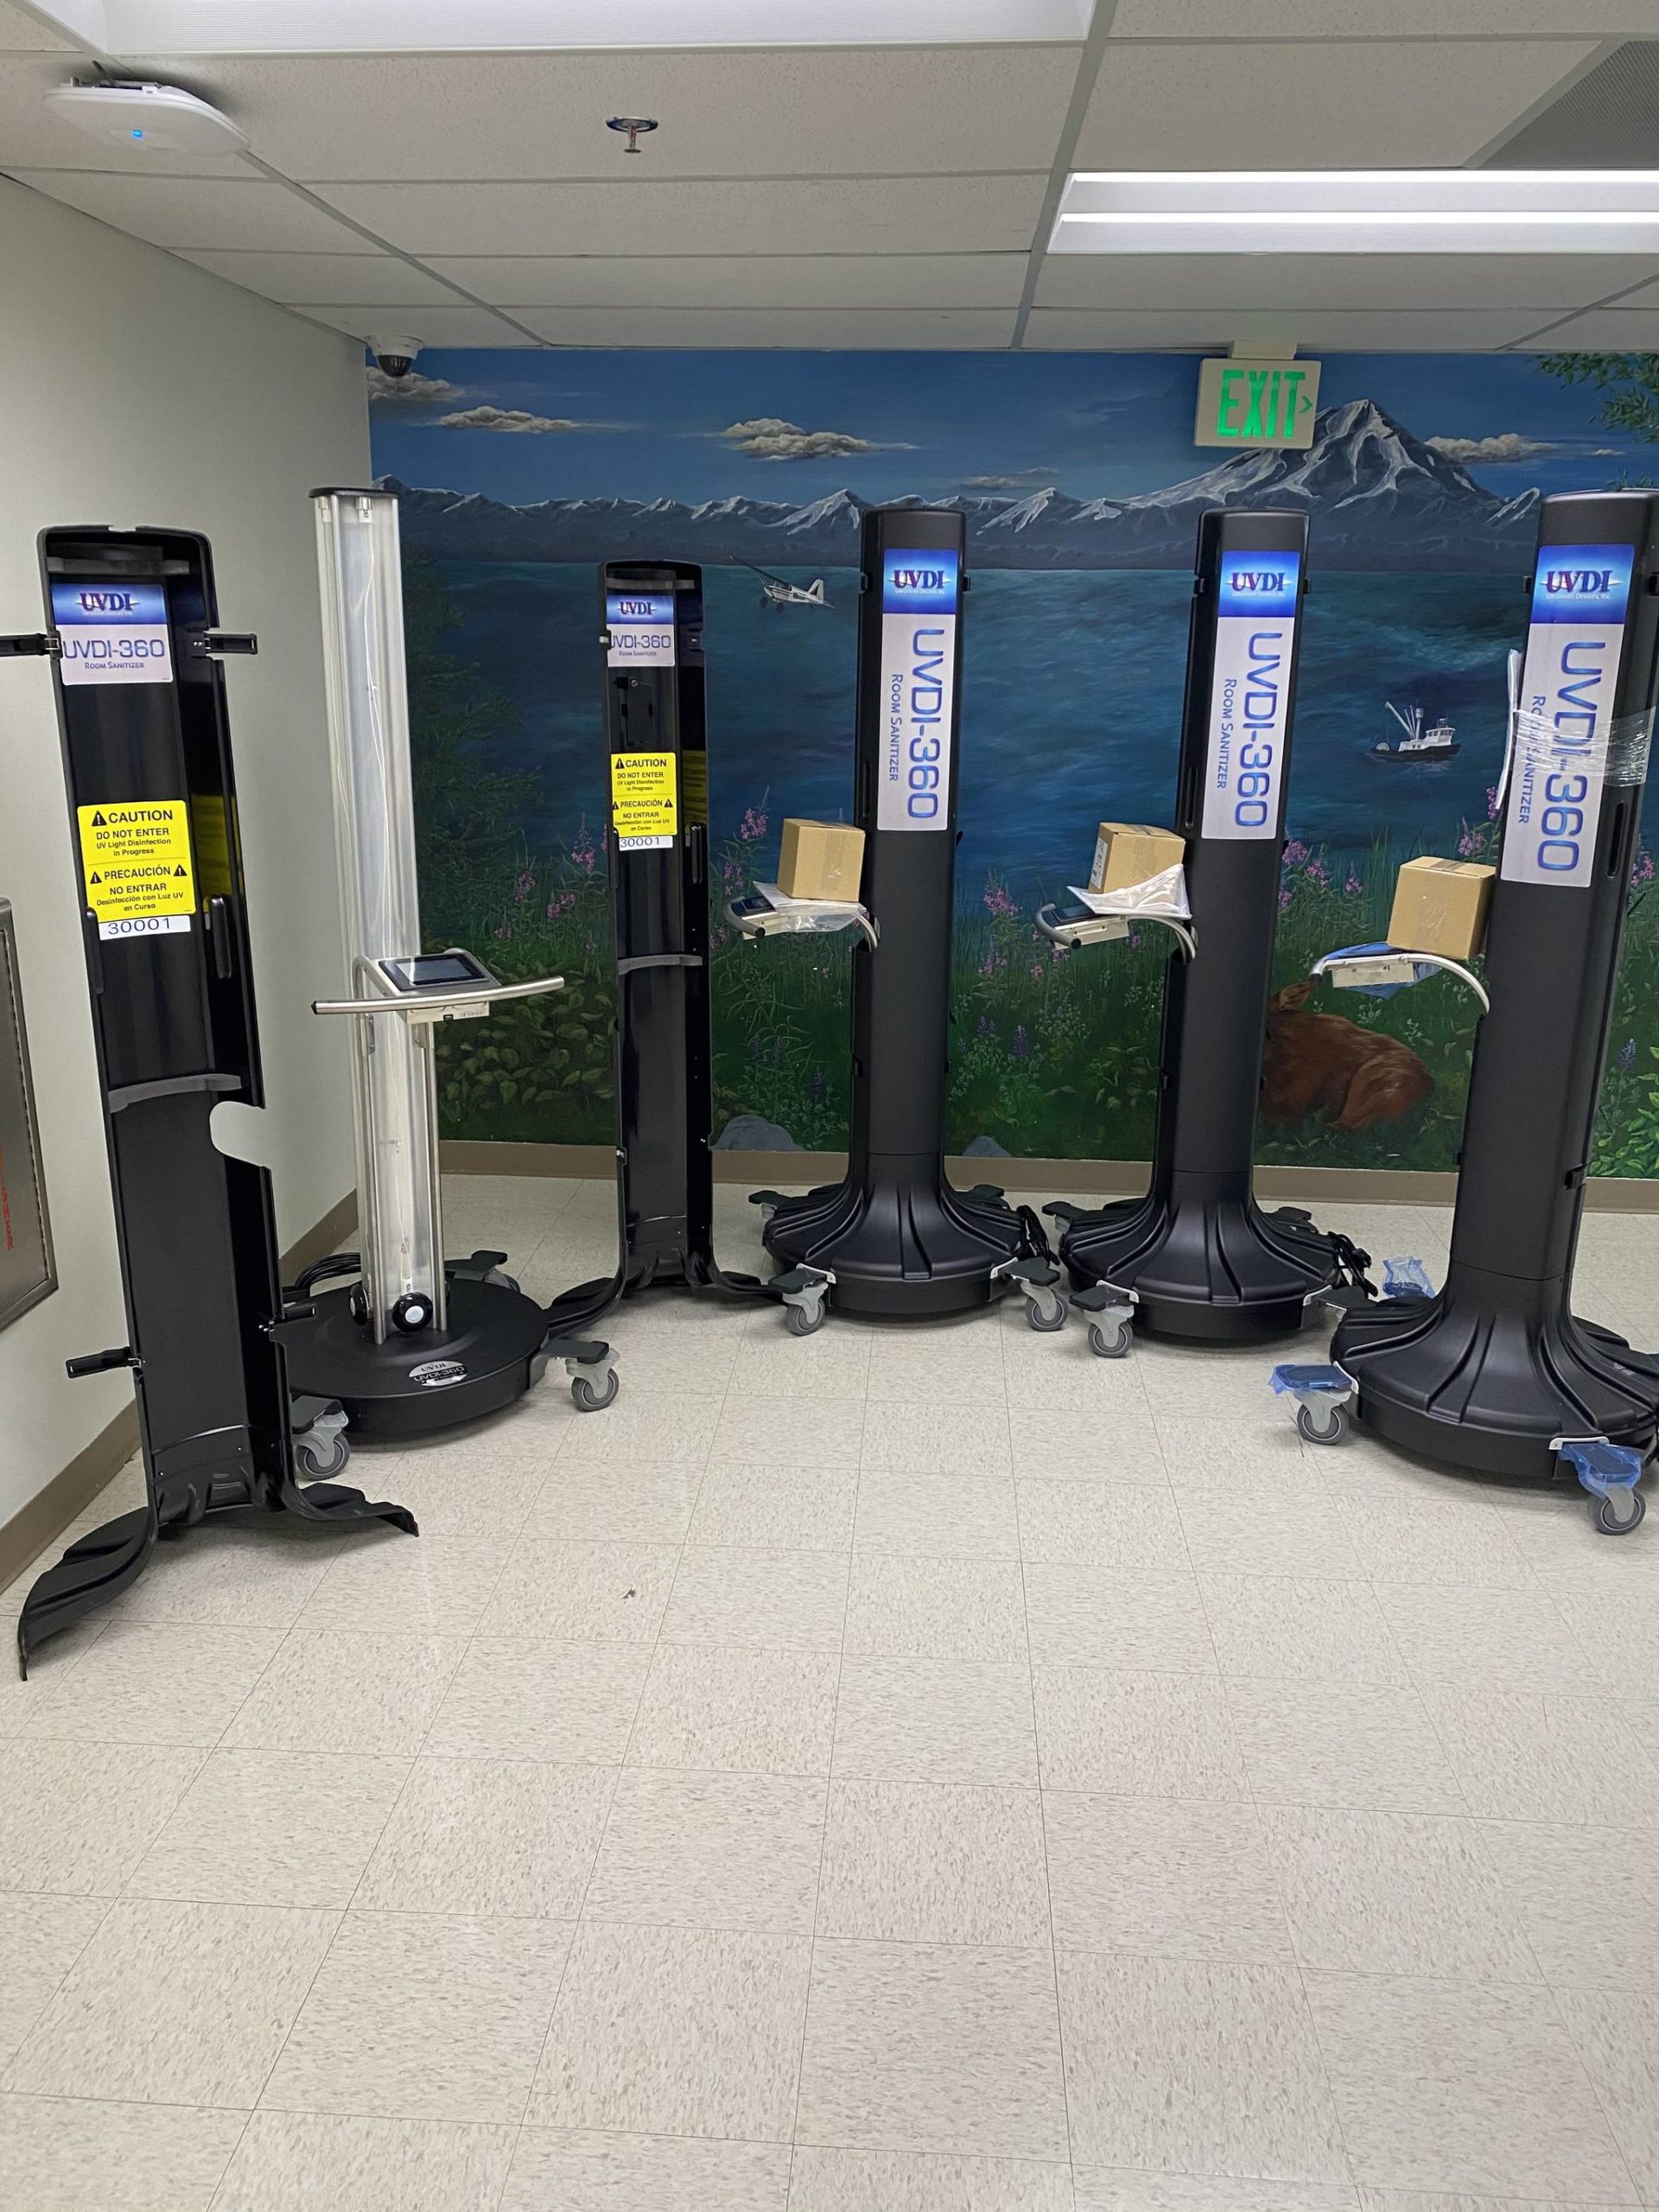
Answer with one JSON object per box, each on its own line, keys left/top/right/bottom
{"left": 283, "top": 1276, "right": 549, "bottom": 1440}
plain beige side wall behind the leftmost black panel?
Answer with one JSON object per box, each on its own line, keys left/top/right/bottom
{"left": 0, "top": 179, "right": 370, "bottom": 1524}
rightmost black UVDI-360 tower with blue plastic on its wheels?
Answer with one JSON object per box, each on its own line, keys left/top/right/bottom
{"left": 1332, "top": 491, "right": 1659, "bottom": 1482}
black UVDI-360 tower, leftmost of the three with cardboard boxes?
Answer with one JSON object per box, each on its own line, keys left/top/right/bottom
{"left": 766, "top": 506, "right": 1028, "bottom": 1316}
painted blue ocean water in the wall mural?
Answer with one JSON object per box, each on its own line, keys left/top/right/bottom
{"left": 440, "top": 560, "right": 1524, "bottom": 900}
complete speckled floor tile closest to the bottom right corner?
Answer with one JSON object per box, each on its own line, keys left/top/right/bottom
{"left": 1307, "top": 1974, "right": 1637, "bottom": 2205}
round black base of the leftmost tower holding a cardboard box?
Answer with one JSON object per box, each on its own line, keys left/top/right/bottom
{"left": 766, "top": 1164, "right": 1024, "bottom": 1320}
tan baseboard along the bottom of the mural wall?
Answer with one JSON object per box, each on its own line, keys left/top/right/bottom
{"left": 440, "top": 1139, "right": 1659, "bottom": 1214}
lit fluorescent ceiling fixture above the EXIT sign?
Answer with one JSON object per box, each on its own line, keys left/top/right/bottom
{"left": 1048, "top": 168, "right": 1659, "bottom": 254}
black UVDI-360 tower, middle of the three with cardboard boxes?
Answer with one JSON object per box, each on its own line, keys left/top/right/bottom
{"left": 1048, "top": 511, "right": 1338, "bottom": 1343}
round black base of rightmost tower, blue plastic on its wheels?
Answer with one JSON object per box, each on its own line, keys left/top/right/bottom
{"left": 1332, "top": 1268, "right": 1659, "bottom": 1484}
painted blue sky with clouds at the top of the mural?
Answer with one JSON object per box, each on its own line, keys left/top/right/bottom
{"left": 374, "top": 349, "right": 1659, "bottom": 505}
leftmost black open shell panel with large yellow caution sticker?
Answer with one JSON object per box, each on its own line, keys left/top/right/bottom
{"left": 7, "top": 529, "right": 416, "bottom": 1663}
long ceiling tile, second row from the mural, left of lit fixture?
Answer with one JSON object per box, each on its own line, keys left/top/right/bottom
{"left": 431, "top": 254, "right": 1026, "bottom": 308}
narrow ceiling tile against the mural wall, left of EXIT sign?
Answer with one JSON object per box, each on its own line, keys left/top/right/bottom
{"left": 518, "top": 308, "right": 1013, "bottom": 349}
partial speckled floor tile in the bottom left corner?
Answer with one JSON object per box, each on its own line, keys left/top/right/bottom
{"left": 0, "top": 2097, "right": 245, "bottom": 2212}
